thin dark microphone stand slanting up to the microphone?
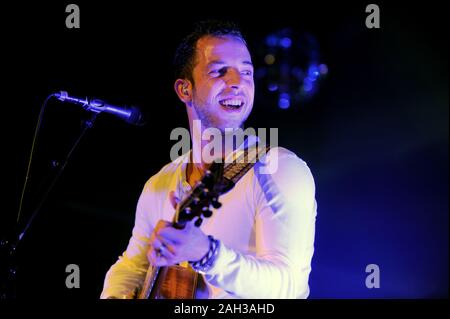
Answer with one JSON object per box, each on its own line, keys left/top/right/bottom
{"left": 0, "top": 113, "right": 99, "bottom": 299}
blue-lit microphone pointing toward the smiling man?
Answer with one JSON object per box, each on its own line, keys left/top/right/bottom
{"left": 53, "top": 91, "right": 145, "bottom": 126}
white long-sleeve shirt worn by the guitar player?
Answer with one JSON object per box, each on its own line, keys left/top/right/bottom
{"left": 101, "top": 147, "right": 317, "bottom": 298}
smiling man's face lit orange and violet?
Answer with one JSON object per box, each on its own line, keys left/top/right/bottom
{"left": 188, "top": 36, "right": 255, "bottom": 132}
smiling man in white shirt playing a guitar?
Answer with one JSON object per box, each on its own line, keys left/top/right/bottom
{"left": 101, "top": 21, "right": 316, "bottom": 298}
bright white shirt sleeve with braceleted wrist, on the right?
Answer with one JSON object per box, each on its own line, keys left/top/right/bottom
{"left": 205, "top": 148, "right": 317, "bottom": 298}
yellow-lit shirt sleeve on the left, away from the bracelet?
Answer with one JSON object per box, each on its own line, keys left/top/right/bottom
{"left": 100, "top": 179, "right": 153, "bottom": 299}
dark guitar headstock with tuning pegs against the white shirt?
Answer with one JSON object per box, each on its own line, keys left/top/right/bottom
{"left": 174, "top": 162, "right": 234, "bottom": 228}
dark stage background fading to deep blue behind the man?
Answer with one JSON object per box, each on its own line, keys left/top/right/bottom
{"left": 0, "top": 1, "right": 448, "bottom": 299}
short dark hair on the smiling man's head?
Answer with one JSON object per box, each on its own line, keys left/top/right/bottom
{"left": 173, "top": 20, "right": 247, "bottom": 84}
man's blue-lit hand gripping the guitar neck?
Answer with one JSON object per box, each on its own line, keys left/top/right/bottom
{"left": 147, "top": 192, "right": 209, "bottom": 267}
